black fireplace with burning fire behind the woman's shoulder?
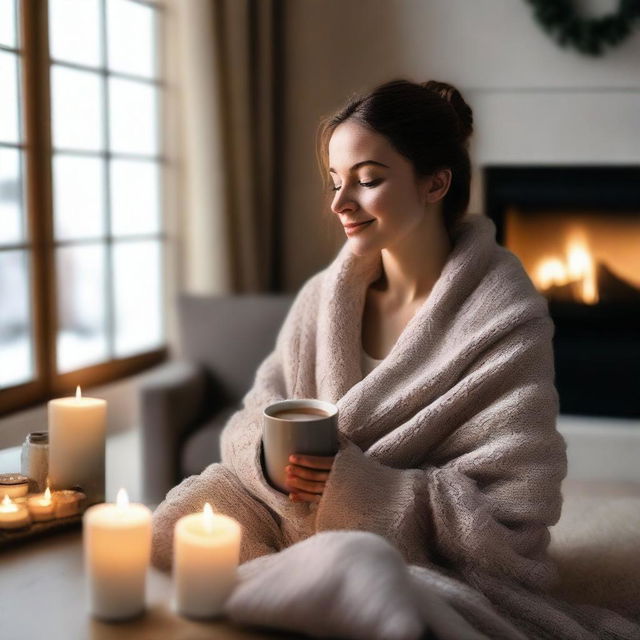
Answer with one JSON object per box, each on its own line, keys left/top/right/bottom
{"left": 484, "top": 166, "right": 640, "bottom": 417}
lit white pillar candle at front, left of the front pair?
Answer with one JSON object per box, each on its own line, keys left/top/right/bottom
{"left": 83, "top": 489, "right": 151, "bottom": 620}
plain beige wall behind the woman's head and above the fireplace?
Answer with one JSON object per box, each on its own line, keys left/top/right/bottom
{"left": 281, "top": 0, "right": 640, "bottom": 290}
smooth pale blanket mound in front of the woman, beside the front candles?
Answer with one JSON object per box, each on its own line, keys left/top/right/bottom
{"left": 225, "top": 531, "right": 492, "bottom": 640}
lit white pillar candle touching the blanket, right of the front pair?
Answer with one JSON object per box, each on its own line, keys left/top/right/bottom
{"left": 173, "top": 503, "right": 242, "bottom": 618}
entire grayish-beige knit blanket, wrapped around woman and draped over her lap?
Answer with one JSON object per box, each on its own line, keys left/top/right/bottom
{"left": 153, "top": 214, "right": 640, "bottom": 640}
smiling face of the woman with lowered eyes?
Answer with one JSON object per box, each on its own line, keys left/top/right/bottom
{"left": 328, "top": 120, "right": 426, "bottom": 255}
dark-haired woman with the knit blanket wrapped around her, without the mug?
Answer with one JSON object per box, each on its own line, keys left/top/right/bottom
{"left": 153, "top": 80, "right": 635, "bottom": 638}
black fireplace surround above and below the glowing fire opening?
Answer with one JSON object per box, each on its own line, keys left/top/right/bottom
{"left": 483, "top": 165, "right": 640, "bottom": 417}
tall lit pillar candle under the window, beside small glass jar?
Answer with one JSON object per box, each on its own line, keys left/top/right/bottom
{"left": 48, "top": 387, "right": 107, "bottom": 504}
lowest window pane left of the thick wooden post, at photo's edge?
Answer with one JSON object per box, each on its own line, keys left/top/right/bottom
{"left": 0, "top": 251, "right": 33, "bottom": 387}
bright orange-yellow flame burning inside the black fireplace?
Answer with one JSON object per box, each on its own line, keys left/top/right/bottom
{"left": 533, "top": 231, "right": 600, "bottom": 304}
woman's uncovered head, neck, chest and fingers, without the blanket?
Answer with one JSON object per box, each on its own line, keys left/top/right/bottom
{"left": 287, "top": 81, "right": 472, "bottom": 502}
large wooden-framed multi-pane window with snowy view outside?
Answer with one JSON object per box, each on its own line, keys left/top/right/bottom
{"left": 0, "top": 0, "right": 166, "bottom": 413}
